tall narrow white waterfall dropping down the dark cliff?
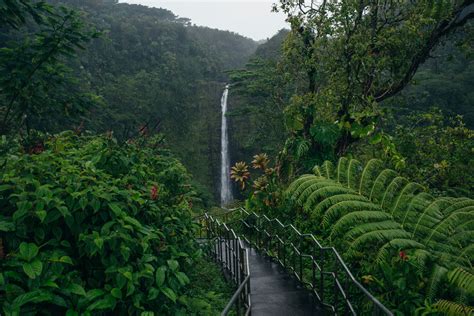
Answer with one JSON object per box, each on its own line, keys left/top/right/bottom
{"left": 221, "top": 85, "right": 232, "bottom": 207}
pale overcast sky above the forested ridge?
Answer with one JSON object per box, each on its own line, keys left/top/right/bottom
{"left": 120, "top": 0, "right": 289, "bottom": 40}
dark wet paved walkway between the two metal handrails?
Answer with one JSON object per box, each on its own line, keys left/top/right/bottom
{"left": 249, "top": 248, "right": 322, "bottom": 316}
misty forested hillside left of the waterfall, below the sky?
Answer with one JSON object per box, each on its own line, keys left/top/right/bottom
{"left": 47, "top": 0, "right": 258, "bottom": 202}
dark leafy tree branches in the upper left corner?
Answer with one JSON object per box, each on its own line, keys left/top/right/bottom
{"left": 0, "top": 1, "right": 97, "bottom": 135}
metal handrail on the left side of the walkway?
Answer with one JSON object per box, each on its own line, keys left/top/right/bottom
{"left": 203, "top": 213, "right": 251, "bottom": 316}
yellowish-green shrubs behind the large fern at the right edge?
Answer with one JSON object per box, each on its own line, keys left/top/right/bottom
{"left": 350, "top": 109, "right": 474, "bottom": 198}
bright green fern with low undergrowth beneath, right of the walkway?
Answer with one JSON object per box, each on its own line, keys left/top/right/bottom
{"left": 287, "top": 158, "right": 474, "bottom": 314}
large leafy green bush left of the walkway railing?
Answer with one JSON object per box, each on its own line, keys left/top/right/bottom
{"left": 0, "top": 132, "right": 209, "bottom": 315}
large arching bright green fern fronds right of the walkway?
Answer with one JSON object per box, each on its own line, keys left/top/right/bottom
{"left": 287, "top": 158, "right": 474, "bottom": 310}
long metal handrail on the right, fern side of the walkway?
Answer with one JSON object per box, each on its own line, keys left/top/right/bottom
{"left": 217, "top": 208, "right": 393, "bottom": 316}
